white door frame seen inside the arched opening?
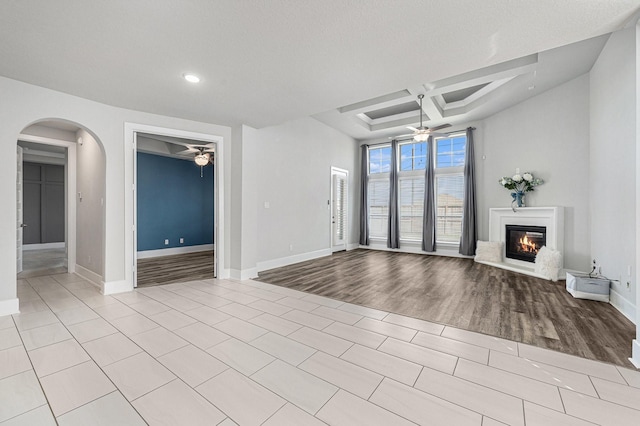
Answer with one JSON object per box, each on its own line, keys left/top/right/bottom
{"left": 16, "top": 133, "right": 77, "bottom": 274}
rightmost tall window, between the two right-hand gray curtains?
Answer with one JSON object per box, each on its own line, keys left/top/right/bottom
{"left": 434, "top": 133, "right": 467, "bottom": 243}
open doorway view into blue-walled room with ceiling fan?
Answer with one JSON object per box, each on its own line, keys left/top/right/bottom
{"left": 134, "top": 132, "right": 217, "bottom": 287}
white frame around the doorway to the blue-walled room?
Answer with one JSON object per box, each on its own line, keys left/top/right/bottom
{"left": 124, "top": 122, "right": 228, "bottom": 292}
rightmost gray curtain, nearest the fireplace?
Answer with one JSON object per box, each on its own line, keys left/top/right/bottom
{"left": 459, "top": 127, "right": 478, "bottom": 256}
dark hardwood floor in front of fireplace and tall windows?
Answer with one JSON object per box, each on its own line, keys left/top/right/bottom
{"left": 258, "top": 249, "right": 635, "bottom": 368}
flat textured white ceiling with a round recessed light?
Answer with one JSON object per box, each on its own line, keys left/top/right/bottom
{"left": 0, "top": 0, "right": 640, "bottom": 131}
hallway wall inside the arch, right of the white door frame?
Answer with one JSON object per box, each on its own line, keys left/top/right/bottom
{"left": 73, "top": 129, "right": 106, "bottom": 279}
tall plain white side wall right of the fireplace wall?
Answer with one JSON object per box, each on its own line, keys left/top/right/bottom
{"left": 589, "top": 27, "right": 638, "bottom": 314}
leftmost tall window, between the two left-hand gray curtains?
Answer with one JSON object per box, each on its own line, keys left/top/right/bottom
{"left": 368, "top": 145, "right": 391, "bottom": 238}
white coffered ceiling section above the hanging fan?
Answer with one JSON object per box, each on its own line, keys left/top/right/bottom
{"left": 314, "top": 35, "right": 608, "bottom": 140}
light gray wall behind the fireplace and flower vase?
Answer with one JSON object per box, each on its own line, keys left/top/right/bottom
{"left": 475, "top": 75, "right": 590, "bottom": 271}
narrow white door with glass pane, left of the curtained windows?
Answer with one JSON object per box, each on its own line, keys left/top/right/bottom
{"left": 331, "top": 167, "right": 349, "bottom": 252}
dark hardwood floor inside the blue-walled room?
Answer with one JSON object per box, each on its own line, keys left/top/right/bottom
{"left": 138, "top": 251, "right": 213, "bottom": 287}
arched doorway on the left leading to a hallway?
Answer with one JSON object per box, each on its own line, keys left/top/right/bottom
{"left": 16, "top": 119, "right": 106, "bottom": 285}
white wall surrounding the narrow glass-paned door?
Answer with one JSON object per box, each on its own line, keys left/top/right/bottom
{"left": 249, "top": 118, "right": 359, "bottom": 265}
